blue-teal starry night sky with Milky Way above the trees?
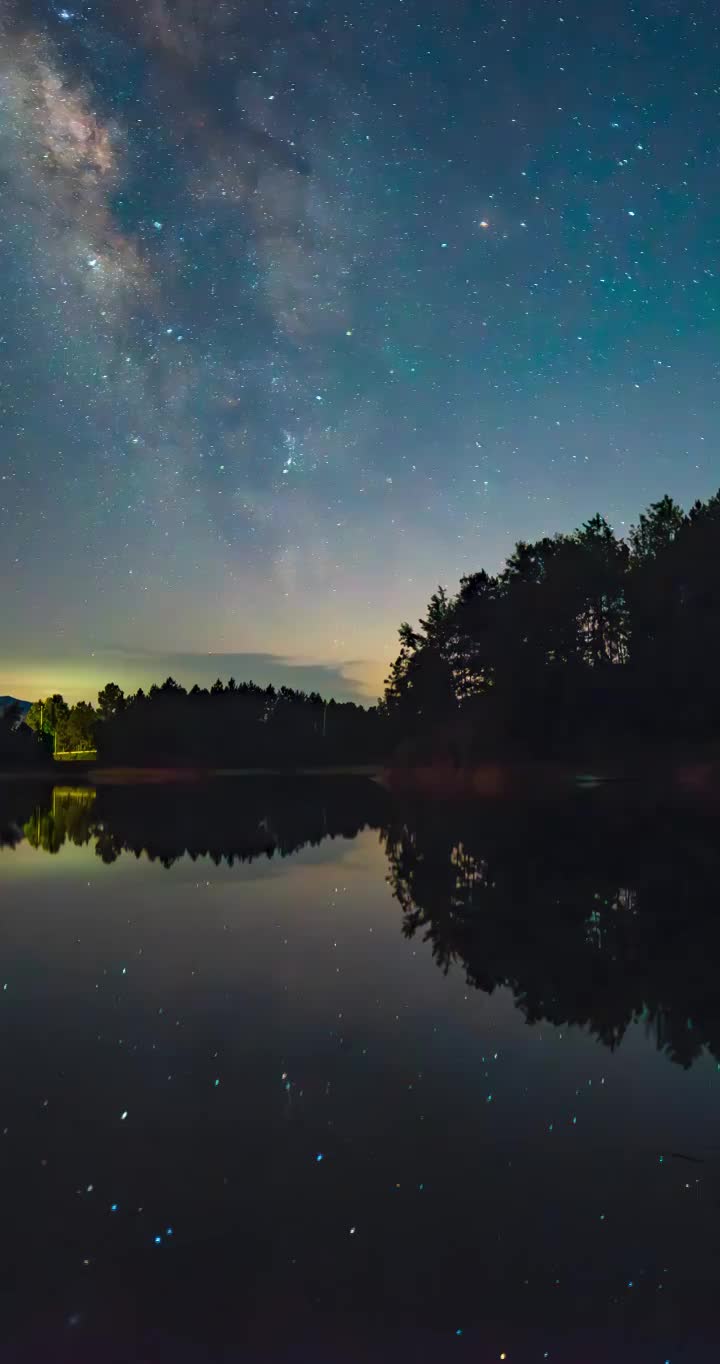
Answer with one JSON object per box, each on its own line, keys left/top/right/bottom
{"left": 0, "top": 0, "right": 720, "bottom": 700}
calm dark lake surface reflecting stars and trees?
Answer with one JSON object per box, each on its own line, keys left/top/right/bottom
{"left": 0, "top": 780, "right": 720, "bottom": 1364}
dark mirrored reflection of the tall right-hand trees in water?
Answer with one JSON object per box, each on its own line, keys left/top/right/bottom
{"left": 386, "top": 797, "right": 720, "bottom": 1065}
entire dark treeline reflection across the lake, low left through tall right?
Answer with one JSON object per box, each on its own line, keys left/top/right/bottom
{"left": 5, "top": 777, "right": 720, "bottom": 1065}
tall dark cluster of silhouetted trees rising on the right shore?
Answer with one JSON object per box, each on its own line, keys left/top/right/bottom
{"left": 380, "top": 494, "right": 720, "bottom": 757}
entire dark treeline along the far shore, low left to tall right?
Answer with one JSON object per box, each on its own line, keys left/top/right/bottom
{"left": 0, "top": 494, "right": 720, "bottom": 798}
